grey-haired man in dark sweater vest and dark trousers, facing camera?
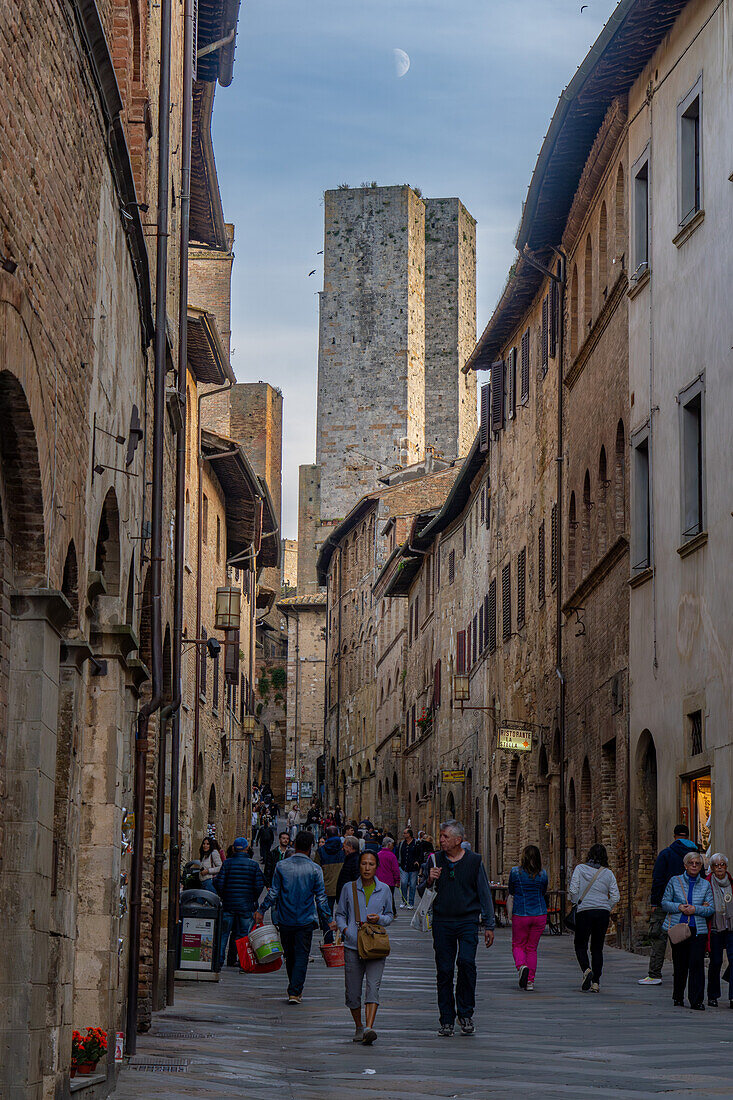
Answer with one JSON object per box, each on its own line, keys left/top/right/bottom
{"left": 427, "top": 821, "right": 494, "bottom": 1038}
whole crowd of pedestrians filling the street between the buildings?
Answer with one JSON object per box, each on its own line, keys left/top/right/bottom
{"left": 184, "top": 789, "right": 733, "bottom": 1045}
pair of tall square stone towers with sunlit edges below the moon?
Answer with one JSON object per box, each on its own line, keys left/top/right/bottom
{"left": 316, "top": 185, "right": 477, "bottom": 520}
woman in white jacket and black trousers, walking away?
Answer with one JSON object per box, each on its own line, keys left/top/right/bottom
{"left": 568, "top": 844, "right": 621, "bottom": 993}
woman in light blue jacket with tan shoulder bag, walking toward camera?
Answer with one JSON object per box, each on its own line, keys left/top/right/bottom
{"left": 333, "top": 851, "right": 393, "bottom": 1046}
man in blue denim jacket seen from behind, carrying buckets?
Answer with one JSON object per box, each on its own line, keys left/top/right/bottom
{"left": 255, "top": 831, "right": 336, "bottom": 1004}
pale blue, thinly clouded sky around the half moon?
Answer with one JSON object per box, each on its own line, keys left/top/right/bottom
{"left": 214, "top": 0, "right": 615, "bottom": 538}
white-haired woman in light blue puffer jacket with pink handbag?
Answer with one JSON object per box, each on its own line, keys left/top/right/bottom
{"left": 661, "top": 851, "right": 715, "bottom": 1012}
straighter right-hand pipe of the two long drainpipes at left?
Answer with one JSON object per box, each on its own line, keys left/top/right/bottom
{"left": 165, "top": 0, "right": 194, "bottom": 1004}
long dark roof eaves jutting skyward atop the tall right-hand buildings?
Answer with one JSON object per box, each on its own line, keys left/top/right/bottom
{"left": 462, "top": 0, "right": 689, "bottom": 373}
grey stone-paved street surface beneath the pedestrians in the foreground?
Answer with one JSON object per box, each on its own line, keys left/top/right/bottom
{"left": 114, "top": 914, "right": 733, "bottom": 1100}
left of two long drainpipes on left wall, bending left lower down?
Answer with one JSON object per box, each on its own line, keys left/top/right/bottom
{"left": 127, "top": 0, "right": 172, "bottom": 1054}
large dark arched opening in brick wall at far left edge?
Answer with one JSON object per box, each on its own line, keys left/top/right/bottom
{"left": 0, "top": 371, "right": 46, "bottom": 589}
